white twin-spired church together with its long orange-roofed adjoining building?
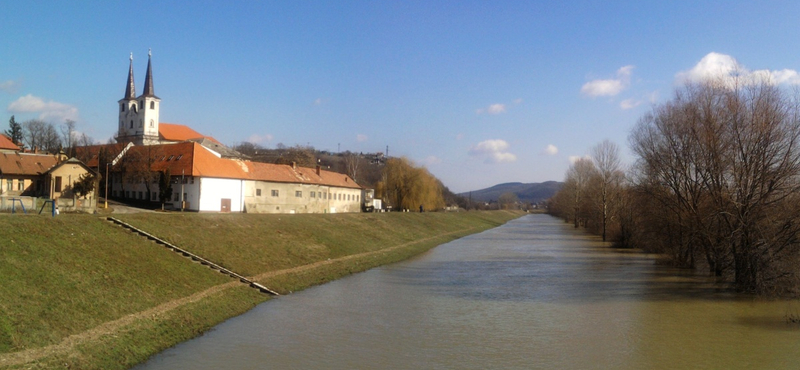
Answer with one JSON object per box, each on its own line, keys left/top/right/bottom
{"left": 79, "top": 53, "right": 373, "bottom": 213}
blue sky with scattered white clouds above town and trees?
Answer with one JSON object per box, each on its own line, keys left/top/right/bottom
{"left": 0, "top": 1, "right": 800, "bottom": 192}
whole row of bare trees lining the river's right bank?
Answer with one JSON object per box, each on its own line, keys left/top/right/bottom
{"left": 550, "top": 78, "right": 800, "bottom": 294}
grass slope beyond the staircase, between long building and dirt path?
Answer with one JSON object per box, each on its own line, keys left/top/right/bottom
{"left": 118, "top": 212, "right": 520, "bottom": 276}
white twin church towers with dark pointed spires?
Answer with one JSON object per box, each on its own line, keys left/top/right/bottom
{"left": 117, "top": 49, "right": 161, "bottom": 145}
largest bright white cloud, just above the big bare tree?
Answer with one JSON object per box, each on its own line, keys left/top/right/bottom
{"left": 675, "top": 52, "right": 800, "bottom": 85}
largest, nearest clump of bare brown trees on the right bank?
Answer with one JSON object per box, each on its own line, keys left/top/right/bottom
{"left": 631, "top": 80, "right": 800, "bottom": 293}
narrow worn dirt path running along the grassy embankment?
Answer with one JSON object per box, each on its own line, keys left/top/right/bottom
{"left": 0, "top": 228, "right": 471, "bottom": 368}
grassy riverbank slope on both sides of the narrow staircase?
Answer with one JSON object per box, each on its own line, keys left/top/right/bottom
{"left": 0, "top": 212, "right": 521, "bottom": 369}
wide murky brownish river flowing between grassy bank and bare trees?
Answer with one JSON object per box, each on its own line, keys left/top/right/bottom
{"left": 136, "top": 215, "right": 800, "bottom": 369}
